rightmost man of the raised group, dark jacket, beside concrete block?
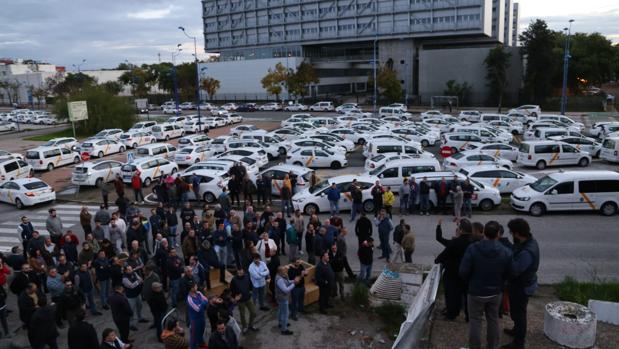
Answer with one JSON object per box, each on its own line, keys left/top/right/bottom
{"left": 503, "top": 218, "right": 540, "bottom": 349}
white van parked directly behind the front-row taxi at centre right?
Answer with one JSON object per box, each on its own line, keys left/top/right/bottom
{"left": 363, "top": 159, "right": 441, "bottom": 188}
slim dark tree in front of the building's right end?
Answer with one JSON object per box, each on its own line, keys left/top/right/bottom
{"left": 484, "top": 44, "right": 511, "bottom": 113}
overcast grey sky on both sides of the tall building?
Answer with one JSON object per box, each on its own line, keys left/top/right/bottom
{"left": 0, "top": 0, "right": 619, "bottom": 69}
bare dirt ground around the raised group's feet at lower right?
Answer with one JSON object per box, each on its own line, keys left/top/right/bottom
{"left": 429, "top": 286, "right": 619, "bottom": 349}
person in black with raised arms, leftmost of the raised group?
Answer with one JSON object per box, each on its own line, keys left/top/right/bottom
{"left": 434, "top": 219, "right": 474, "bottom": 321}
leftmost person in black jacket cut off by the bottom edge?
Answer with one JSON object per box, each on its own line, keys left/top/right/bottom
{"left": 28, "top": 295, "right": 58, "bottom": 349}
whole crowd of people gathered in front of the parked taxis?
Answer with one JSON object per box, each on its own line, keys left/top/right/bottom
{"left": 0, "top": 159, "right": 539, "bottom": 349}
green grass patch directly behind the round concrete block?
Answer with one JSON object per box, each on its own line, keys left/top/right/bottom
{"left": 554, "top": 277, "right": 619, "bottom": 306}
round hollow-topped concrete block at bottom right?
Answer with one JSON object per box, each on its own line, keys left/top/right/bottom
{"left": 544, "top": 302, "right": 597, "bottom": 348}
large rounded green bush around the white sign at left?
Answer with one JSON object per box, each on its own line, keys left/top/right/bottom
{"left": 54, "top": 85, "right": 137, "bottom": 135}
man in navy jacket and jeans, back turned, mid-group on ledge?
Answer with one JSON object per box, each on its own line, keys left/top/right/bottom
{"left": 459, "top": 221, "right": 511, "bottom": 349}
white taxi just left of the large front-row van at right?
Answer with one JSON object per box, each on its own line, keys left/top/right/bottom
{"left": 460, "top": 165, "right": 537, "bottom": 194}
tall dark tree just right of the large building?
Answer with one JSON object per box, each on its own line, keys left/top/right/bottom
{"left": 519, "top": 19, "right": 561, "bottom": 104}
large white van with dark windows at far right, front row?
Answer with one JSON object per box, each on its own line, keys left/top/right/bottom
{"left": 511, "top": 171, "right": 619, "bottom": 216}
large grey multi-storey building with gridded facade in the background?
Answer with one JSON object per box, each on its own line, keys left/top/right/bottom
{"left": 201, "top": 0, "right": 512, "bottom": 102}
